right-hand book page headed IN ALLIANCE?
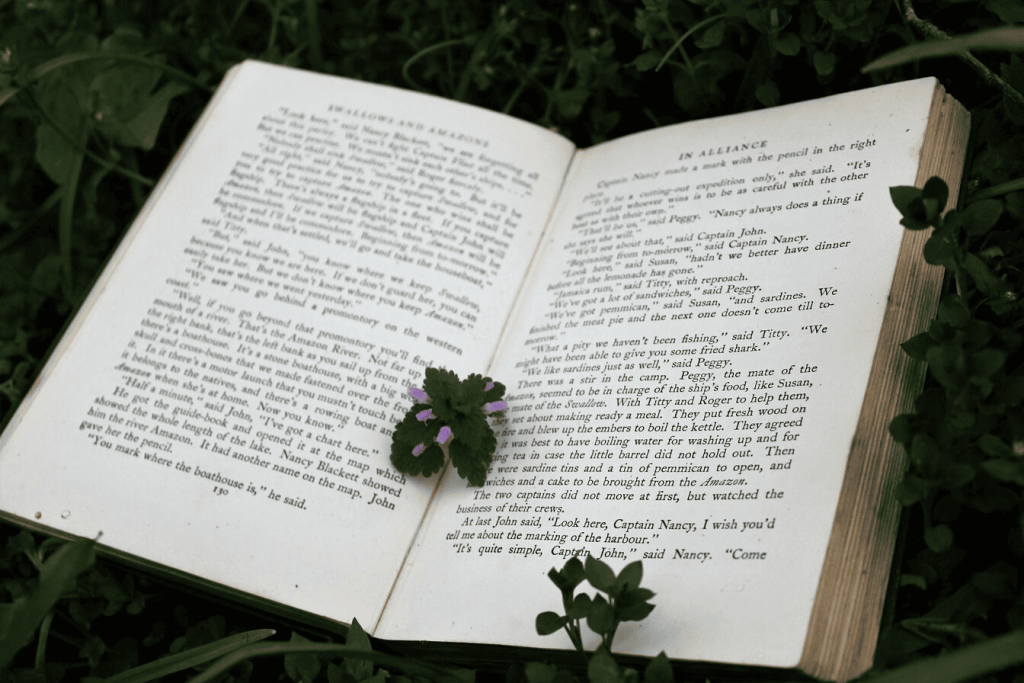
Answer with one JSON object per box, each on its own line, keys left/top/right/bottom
{"left": 379, "top": 80, "right": 935, "bottom": 667}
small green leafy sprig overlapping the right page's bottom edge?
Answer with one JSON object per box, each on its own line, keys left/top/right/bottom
{"left": 523, "top": 555, "right": 673, "bottom": 683}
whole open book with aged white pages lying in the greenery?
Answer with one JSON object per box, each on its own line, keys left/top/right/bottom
{"left": 0, "top": 61, "right": 967, "bottom": 680}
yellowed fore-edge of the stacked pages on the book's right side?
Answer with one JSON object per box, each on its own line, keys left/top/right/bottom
{"left": 798, "top": 83, "right": 970, "bottom": 683}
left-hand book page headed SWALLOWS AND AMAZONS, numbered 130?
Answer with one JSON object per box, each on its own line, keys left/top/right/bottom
{"left": 0, "top": 61, "right": 573, "bottom": 624}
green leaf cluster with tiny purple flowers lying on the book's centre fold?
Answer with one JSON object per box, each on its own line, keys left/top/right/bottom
{"left": 391, "top": 368, "right": 507, "bottom": 486}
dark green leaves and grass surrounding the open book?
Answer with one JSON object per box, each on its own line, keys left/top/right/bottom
{"left": 0, "top": 0, "right": 1024, "bottom": 683}
